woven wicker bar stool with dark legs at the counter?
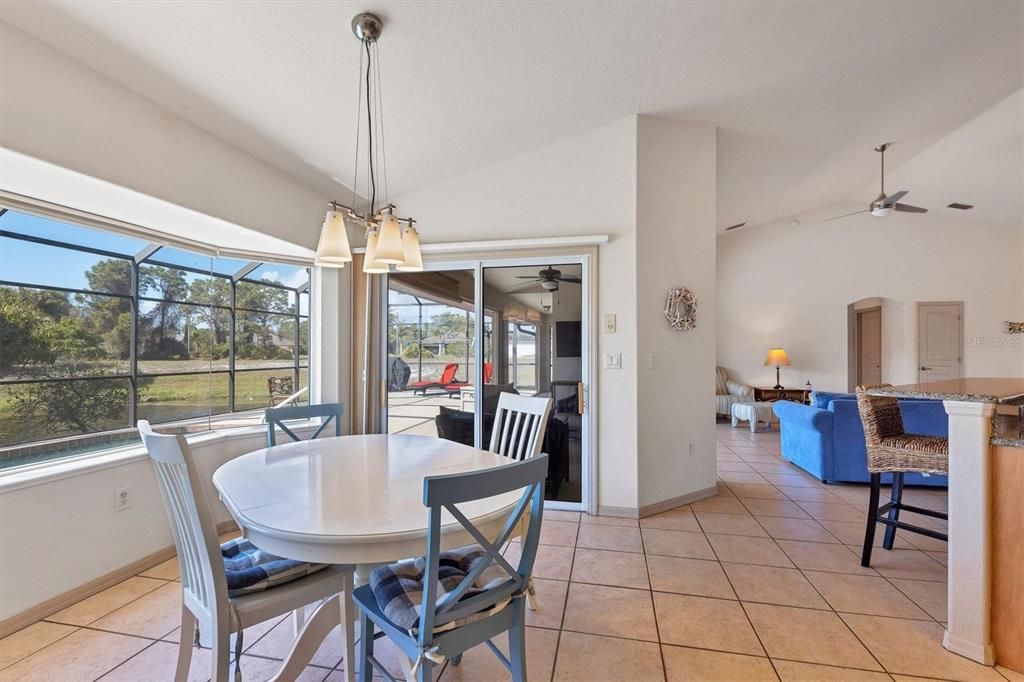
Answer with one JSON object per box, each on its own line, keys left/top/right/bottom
{"left": 857, "top": 384, "right": 949, "bottom": 566}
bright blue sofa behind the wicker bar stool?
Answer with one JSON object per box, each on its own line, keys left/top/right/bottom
{"left": 774, "top": 391, "right": 949, "bottom": 487}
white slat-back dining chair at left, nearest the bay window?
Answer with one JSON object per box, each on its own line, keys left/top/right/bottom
{"left": 138, "top": 420, "right": 355, "bottom": 682}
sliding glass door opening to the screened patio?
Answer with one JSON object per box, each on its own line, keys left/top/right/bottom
{"left": 382, "top": 257, "right": 592, "bottom": 510}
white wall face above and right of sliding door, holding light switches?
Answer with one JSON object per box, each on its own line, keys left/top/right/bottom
{"left": 395, "top": 117, "right": 638, "bottom": 508}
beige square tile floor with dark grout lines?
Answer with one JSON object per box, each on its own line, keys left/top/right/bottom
{"left": 0, "top": 424, "right": 1022, "bottom": 682}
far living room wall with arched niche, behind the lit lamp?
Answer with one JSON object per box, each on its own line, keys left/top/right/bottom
{"left": 718, "top": 206, "right": 1024, "bottom": 390}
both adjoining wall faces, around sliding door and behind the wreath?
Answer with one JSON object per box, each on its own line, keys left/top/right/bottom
{"left": 396, "top": 117, "right": 716, "bottom": 512}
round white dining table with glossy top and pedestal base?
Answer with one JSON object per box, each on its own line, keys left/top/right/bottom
{"left": 213, "top": 434, "right": 521, "bottom": 680}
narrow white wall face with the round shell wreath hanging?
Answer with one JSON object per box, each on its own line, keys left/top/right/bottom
{"left": 636, "top": 116, "right": 716, "bottom": 507}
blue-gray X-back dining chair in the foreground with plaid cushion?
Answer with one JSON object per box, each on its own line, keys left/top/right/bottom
{"left": 353, "top": 455, "right": 548, "bottom": 682}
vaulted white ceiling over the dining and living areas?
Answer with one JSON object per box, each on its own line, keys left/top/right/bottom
{"left": 0, "top": 0, "right": 1024, "bottom": 228}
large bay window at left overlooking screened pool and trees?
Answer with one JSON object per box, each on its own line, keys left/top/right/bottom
{"left": 0, "top": 208, "right": 309, "bottom": 468}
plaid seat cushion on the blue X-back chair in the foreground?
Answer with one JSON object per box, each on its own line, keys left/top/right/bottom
{"left": 370, "top": 545, "right": 511, "bottom": 634}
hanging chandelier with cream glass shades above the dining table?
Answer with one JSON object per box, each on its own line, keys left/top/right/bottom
{"left": 313, "top": 12, "right": 423, "bottom": 274}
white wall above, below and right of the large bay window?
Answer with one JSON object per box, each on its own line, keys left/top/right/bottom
{"left": 0, "top": 23, "right": 361, "bottom": 620}
